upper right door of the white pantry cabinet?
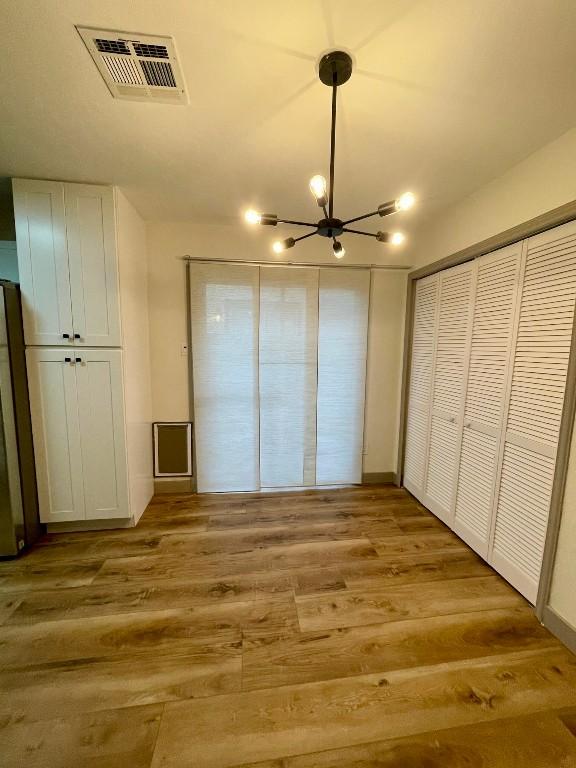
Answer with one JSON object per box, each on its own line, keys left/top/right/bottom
{"left": 64, "top": 184, "right": 121, "bottom": 347}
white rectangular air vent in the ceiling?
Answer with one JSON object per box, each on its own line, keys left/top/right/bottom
{"left": 76, "top": 27, "right": 188, "bottom": 104}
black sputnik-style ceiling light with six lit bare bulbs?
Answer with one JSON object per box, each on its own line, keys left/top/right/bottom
{"left": 244, "top": 51, "right": 415, "bottom": 259}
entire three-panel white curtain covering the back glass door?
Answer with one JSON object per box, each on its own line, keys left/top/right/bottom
{"left": 190, "top": 263, "right": 370, "bottom": 492}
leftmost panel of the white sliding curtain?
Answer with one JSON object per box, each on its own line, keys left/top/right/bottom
{"left": 190, "top": 264, "right": 260, "bottom": 492}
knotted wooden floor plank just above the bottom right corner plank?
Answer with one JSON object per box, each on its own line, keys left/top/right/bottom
{"left": 152, "top": 651, "right": 576, "bottom": 768}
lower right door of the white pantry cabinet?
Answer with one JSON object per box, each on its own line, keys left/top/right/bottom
{"left": 75, "top": 348, "right": 130, "bottom": 520}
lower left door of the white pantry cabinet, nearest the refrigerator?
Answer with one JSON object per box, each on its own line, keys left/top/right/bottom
{"left": 26, "top": 348, "right": 85, "bottom": 523}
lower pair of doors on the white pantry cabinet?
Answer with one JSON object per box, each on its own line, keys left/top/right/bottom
{"left": 26, "top": 347, "right": 130, "bottom": 523}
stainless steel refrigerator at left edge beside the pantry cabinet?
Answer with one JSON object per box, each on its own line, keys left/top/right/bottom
{"left": 0, "top": 280, "right": 43, "bottom": 557}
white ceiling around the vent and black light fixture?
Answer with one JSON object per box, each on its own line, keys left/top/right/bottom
{"left": 0, "top": 0, "right": 576, "bottom": 236}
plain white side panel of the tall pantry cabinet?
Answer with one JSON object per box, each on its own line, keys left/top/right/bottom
{"left": 116, "top": 190, "right": 154, "bottom": 522}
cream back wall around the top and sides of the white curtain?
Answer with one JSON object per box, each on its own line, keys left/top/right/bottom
{"left": 147, "top": 222, "right": 406, "bottom": 472}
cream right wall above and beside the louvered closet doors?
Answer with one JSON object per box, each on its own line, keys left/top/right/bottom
{"left": 411, "top": 129, "right": 576, "bottom": 629}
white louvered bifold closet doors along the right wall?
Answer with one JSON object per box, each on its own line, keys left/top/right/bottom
{"left": 404, "top": 222, "right": 576, "bottom": 602}
